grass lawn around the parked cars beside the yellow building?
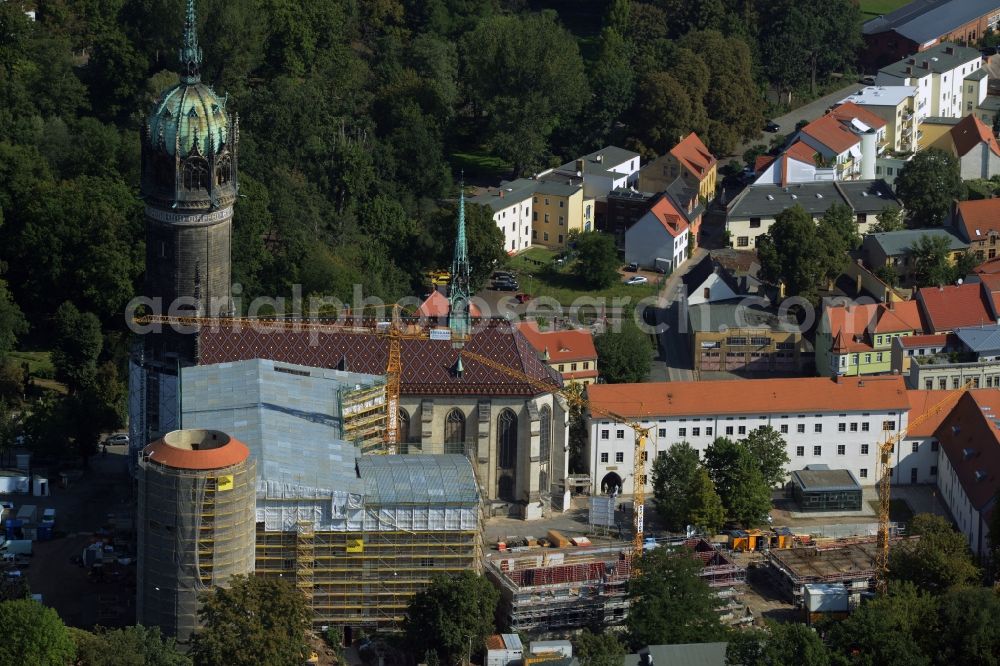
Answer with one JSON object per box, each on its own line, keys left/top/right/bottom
{"left": 510, "top": 247, "right": 662, "bottom": 306}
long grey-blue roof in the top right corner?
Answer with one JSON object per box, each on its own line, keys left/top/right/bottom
{"left": 861, "top": 0, "right": 1000, "bottom": 44}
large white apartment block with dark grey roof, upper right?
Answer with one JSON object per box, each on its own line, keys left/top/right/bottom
{"left": 875, "top": 42, "right": 986, "bottom": 124}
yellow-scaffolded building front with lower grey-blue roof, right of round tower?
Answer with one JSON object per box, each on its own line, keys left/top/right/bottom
{"left": 256, "top": 456, "right": 482, "bottom": 630}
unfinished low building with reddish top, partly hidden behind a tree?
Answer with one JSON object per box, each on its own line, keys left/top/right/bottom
{"left": 485, "top": 539, "right": 752, "bottom": 636}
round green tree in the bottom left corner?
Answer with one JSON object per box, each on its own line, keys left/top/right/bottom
{"left": 0, "top": 599, "right": 76, "bottom": 666}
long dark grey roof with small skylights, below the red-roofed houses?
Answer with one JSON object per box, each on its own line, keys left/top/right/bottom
{"left": 728, "top": 179, "right": 900, "bottom": 218}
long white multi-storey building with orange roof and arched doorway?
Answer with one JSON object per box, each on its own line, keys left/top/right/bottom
{"left": 585, "top": 375, "right": 910, "bottom": 494}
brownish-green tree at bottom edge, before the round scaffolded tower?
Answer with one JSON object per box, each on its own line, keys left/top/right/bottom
{"left": 191, "top": 575, "right": 312, "bottom": 666}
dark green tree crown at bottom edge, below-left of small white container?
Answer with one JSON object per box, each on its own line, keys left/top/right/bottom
{"left": 726, "top": 622, "right": 830, "bottom": 666}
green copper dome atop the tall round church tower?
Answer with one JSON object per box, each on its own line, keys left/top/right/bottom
{"left": 148, "top": 81, "right": 229, "bottom": 157}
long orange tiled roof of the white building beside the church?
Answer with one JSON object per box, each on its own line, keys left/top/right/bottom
{"left": 587, "top": 376, "right": 910, "bottom": 418}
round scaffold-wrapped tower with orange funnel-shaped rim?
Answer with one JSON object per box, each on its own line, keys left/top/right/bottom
{"left": 136, "top": 430, "right": 256, "bottom": 642}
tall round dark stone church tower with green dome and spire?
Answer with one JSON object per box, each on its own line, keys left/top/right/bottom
{"left": 140, "top": 0, "right": 239, "bottom": 324}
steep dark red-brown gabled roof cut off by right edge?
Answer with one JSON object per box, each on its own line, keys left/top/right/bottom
{"left": 936, "top": 389, "right": 1000, "bottom": 509}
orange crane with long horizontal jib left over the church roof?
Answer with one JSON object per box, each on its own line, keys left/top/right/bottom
{"left": 134, "top": 305, "right": 444, "bottom": 453}
